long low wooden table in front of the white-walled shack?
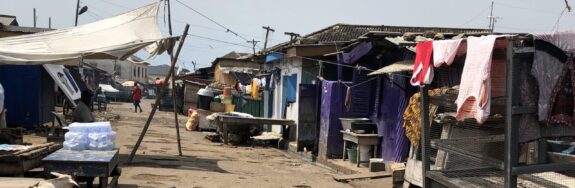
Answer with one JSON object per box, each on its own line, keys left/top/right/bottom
{"left": 216, "top": 116, "right": 296, "bottom": 144}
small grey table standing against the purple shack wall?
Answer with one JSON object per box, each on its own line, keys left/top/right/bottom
{"left": 340, "top": 130, "right": 381, "bottom": 167}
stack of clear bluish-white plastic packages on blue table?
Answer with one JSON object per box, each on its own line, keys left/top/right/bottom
{"left": 64, "top": 122, "right": 116, "bottom": 151}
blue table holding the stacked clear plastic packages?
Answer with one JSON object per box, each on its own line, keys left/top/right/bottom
{"left": 42, "top": 149, "right": 120, "bottom": 187}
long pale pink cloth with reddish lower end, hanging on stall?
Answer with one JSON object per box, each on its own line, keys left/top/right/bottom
{"left": 455, "top": 35, "right": 497, "bottom": 124}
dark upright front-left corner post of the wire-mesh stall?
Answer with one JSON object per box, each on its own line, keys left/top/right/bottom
{"left": 420, "top": 86, "right": 431, "bottom": 188}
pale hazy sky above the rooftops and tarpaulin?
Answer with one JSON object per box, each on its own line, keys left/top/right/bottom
{"left": 0, "top": 0, "right": 575, "bottom": 69}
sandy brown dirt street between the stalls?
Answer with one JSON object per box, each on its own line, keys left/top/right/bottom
{"left": 108, "top": 100, "right": 360, "bottom": 188}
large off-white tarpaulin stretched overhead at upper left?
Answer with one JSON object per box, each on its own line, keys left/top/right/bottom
{"left": 0, "top": 3, "right": 167, "bottom": 65}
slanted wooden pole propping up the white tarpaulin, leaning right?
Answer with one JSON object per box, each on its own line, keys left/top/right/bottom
{"left": 128, "top": 24, "right": 190, "bottom": 163}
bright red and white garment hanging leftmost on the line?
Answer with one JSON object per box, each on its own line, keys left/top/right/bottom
{"left": 410, "top": 41, "right": 433, "bottom": 86}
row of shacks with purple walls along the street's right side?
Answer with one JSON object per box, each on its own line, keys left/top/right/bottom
{"left": 182, "top": 24, "right": 575, "bottom": 187}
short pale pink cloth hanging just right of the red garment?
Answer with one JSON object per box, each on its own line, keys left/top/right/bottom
{"left": 433, "top": 39, "right": 462, "bottom": 67}
